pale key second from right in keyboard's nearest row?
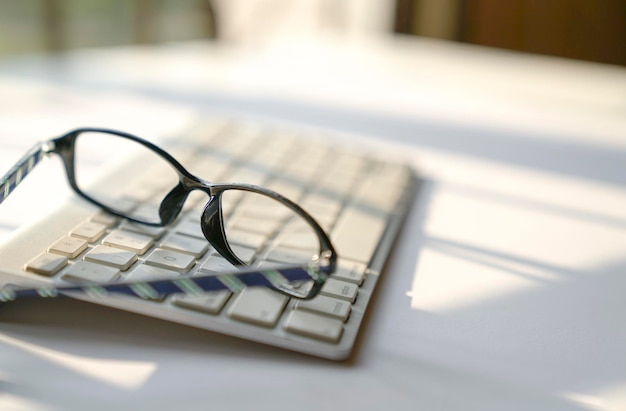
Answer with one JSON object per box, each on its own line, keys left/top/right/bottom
{"left": 228, "top": 288, "right": 288, "bottom": 327}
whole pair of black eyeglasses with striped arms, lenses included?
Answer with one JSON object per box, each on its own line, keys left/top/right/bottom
{"left": 0, "top": 128, "right": 337, "bottom": 301}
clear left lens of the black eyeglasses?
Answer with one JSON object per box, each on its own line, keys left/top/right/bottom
{"left": 74, "top": 132, "right": 178, "bottom": 223}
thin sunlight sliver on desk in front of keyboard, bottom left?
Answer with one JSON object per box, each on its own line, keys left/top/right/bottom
{"left": 0, "top": 334, "right": 157, "bottom": 392}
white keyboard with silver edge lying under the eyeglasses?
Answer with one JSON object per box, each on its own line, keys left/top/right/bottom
{"left": 0, "top": 120, "right": 416, "bottom": 360}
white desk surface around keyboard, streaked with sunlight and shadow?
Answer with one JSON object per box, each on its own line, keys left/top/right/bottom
{"left": 0, "top": 38, "right": 626, "bottom": 411}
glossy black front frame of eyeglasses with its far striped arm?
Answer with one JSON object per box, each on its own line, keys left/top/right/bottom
{"left": 0, "top": 128, "right": 337, "bottom": 299}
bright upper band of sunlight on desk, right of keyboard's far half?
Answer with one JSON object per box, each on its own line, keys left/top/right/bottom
{"left": 424, "top": 182, "right": 626, "bottom": 270}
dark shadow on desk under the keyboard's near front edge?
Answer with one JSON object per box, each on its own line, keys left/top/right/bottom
{"left": 1, "top": 298, "right": 336, "bottom": 363}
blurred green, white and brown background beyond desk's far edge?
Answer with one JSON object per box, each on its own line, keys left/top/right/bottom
{"left": 0, "top": 0, "right": 626, "bottom": 65}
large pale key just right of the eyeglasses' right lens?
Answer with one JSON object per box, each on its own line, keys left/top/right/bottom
{"left": 331, "top": 205, "right": 387, "bottom": 263}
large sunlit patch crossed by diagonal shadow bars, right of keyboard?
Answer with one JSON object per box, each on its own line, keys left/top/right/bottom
{"left": 408, "top": 163, "right": 626, "bottom": 312}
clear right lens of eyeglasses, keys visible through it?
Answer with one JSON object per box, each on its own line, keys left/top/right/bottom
{"left": 222, "top": 190, "right": 319, "bottom": 267}
